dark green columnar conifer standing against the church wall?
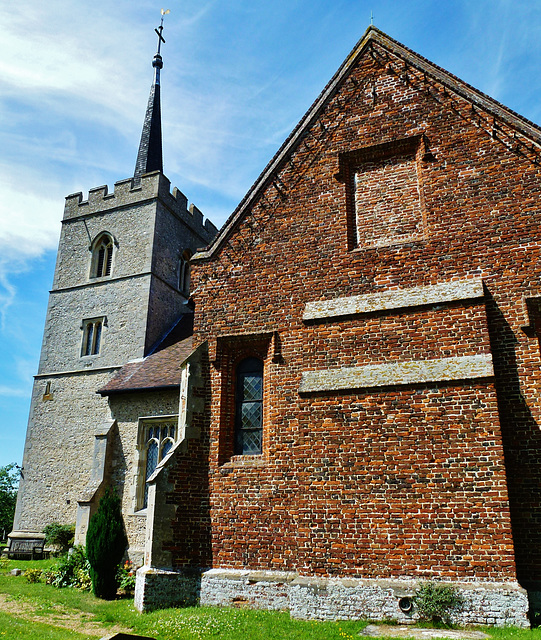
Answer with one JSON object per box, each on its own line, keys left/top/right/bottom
{"left": 86, "top": 489, "right": 128, "bottom": 600}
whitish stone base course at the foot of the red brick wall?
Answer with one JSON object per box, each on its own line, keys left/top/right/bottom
{"left": 135, "top": 567, "right": 529, "bottom": 627}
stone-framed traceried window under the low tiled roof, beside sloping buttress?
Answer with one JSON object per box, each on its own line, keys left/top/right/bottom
{"left": 136, "top": 416, "right": 178, "bottom": 510}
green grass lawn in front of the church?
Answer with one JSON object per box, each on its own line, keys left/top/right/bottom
{"left": 0, "top": 560, "right": 541, "bottom": 640}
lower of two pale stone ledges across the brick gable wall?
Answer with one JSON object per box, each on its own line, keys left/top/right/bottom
{"left": 299, "top": 353, "right": 494, "bottom": 393}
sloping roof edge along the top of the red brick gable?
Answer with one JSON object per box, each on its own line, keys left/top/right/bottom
{"left": 192, "top": 26, "right": 541, "bottom": 262}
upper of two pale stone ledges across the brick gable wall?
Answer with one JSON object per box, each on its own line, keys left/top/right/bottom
{"left": 302, "top": 279, "right": 484, "bottom": 321}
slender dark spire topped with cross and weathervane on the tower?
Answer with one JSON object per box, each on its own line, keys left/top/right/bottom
{"left": 133, "top": 9, "right": 169, "bottom": 182}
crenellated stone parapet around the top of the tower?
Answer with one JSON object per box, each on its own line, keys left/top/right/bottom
{"left": 64, "top": 171, "right": 218, "bottom": 243}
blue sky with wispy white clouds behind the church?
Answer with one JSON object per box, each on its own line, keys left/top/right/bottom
{"left": 0, "top": 0, "right": 541, "bottom": 465}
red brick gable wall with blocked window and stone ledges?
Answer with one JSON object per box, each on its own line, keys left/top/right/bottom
{"left": 178, "top": 37, "right": 541, "bottom": 581}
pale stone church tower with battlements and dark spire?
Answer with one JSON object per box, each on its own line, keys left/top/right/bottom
{"left": 12, "top": 21, "right": 216, "bottom": 535}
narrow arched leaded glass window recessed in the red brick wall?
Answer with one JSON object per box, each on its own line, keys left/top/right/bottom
{"left": 235, "top": 358, "right": 263, "bottom": 455}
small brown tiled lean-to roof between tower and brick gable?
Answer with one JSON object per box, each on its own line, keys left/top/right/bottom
{"left": 98, "top": 313, "right": 193, "bottom": 396}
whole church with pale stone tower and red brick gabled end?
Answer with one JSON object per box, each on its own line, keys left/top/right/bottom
{"left": 14, "top": 27, "right": 541, "bottom": 626}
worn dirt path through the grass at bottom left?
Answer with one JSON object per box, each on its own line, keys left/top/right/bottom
{"left": 0, "top": 593, "right": 131, "bottom": 638}
